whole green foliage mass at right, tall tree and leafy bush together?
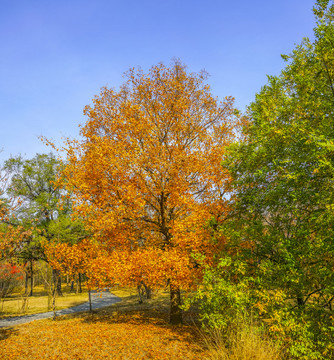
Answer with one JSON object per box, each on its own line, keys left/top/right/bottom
{"left": 198, "top": 1, "right": 334, "bottom": 360}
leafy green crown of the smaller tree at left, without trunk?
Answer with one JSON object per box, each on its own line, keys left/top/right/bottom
{"left": 4, "top": 154, "right": 61, "bottom": 262}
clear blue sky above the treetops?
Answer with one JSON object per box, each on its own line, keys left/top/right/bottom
{"left": 0, "top": 0, "right": 315, "bottom": 161}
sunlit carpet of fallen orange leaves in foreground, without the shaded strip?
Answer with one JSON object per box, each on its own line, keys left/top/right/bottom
{"left": 0, "top": 315, "right": 206, "bottom": 360}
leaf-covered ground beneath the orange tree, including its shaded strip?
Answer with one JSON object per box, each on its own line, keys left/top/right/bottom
{"left": 0, "top": 289, "right": 208, "bottom": 360}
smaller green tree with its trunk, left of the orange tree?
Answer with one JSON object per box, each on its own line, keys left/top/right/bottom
{"left": 4, "top": 153, "right": 76, "bottom": 295}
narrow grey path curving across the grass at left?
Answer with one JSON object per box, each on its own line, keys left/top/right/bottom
{"left": 0, "top": 291, "right": 121, "bottom": 328}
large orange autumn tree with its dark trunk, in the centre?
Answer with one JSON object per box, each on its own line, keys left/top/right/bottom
{"left": 54, "top": 61, "right": 236, "bottom": 323}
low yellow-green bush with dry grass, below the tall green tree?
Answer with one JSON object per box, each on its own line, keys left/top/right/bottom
{"left": 187, "top": 257, "right": 334, "bottom": 360}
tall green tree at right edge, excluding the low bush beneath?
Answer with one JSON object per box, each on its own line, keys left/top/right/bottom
{"left": 217, "top": 0, "right": 334, "bottom": 359}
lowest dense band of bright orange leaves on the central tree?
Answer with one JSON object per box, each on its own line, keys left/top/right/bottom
{"left": 43, "top": 240, "right": 199, "bottom": 288}
